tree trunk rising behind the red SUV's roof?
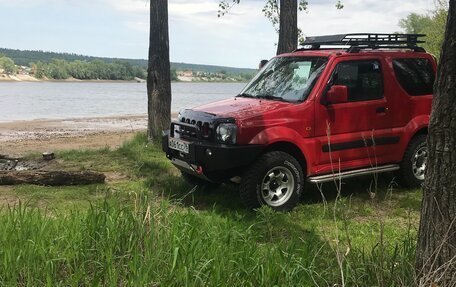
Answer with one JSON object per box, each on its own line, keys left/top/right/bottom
{"left": 277, "top": 0, "right": 298, "bottom": 55}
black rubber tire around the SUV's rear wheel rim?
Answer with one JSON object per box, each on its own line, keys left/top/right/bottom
{"left": 398, "top": 135, "right": 427, "bottom": 188}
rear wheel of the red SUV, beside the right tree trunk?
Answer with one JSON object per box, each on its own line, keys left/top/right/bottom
{"left": 399, "top": 135, "right": 428, "bottom": 188}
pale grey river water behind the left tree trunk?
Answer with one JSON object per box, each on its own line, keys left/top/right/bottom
{"left": 0, "top": 82, "right": 245, "bottom": 122}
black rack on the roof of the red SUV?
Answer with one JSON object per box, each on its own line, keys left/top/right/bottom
{"left": 298, "top": 33, "right": 426, "bottom": 53}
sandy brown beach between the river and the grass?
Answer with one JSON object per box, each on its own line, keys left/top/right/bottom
{"left": 0, "top": 115, "right": 147, "bottom": 155}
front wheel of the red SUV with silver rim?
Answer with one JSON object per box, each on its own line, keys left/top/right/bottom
{"left": 240, "top": 151, "right": 304, "bottom": 211}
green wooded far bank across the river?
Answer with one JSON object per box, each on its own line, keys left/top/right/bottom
{"left": 0, "top": 48, "right": 257, "bottom": 82}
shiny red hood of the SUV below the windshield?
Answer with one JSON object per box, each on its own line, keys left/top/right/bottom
{"left": 192, "top": 97, "right": 292, "bottom": 120}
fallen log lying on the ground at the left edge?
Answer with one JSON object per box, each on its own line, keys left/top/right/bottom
{"left": 0, "top": 170, "right": 106, "bottom": 186}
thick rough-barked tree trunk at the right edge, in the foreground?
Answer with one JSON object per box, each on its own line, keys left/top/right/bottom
{"left": 416, "top": 0, "right": 456, "bottom": 286}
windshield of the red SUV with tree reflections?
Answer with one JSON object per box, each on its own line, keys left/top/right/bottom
{"left": 238, "top": 57, "right": 328, "bottom": 102}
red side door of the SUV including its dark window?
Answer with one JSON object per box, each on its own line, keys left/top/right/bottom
{"left": 315, "top": 57, "right": 398, "bottom": 173}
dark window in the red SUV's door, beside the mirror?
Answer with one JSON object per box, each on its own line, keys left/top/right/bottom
{"left": 332, "top": 60, "right": 383, "bottom": 102}
